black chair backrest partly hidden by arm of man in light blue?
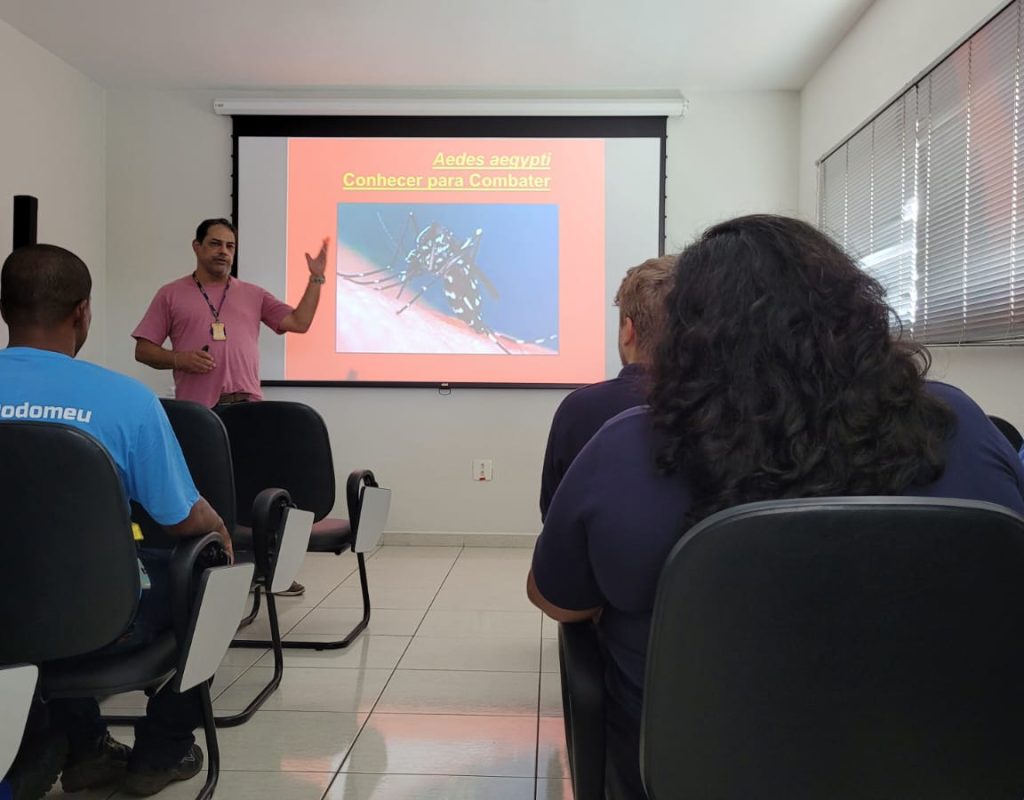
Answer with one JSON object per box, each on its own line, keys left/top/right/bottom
{"left": 132, "top": 399, "right": 236, "bottom": 547}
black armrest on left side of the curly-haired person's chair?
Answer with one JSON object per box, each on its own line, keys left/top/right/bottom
{"left": 558, "top": 620, "right": 605, "bottom": 798}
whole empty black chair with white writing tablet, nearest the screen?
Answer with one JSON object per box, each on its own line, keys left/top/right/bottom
{"left": 218, "top": 401, "right": 390, "bottom": 650}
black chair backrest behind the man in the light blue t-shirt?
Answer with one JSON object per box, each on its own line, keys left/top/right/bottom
{"left": 0, "top": 422, "right": 139, "bottom": 664}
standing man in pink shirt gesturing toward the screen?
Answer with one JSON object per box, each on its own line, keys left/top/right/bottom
{"left": 132, "top": 219, "right": 329, "bottom": 407}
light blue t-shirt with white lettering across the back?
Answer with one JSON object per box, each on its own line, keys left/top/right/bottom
{"left": 0, "top": 347, "right": 199, "bottom": 525}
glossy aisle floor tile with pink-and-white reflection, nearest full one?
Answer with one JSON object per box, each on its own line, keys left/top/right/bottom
{"left": 342, "top": 713, "right": 537, "bottom": 777}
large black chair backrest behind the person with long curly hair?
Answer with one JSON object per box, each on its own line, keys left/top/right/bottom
{"left": 641, "top": 498, "right": 1024, "bottom": 800}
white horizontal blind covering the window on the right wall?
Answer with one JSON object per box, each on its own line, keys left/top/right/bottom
{"left": 818, "top": 0, "right": 1024, "bottom": 343}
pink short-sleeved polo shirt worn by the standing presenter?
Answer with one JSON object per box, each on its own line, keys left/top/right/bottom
{"left": 132, "top": 275, "right": 293, "bottom": 407}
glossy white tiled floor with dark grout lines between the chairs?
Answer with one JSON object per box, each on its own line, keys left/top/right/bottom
{"left": 49, "top": 547, "right": 572, "bottom": 800}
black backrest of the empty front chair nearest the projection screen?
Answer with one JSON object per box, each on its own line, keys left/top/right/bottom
{"left": 217, "top": 401, "right": 335, "bottom": 528}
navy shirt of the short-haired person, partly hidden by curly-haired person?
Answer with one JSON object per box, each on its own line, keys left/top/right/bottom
{"left": 541, "top": 364, "right": 648, "bottom": 520}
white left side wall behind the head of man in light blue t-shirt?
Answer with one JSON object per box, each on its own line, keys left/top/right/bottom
{"left": 0, "top": 20, "right": 106, "bottom": 363}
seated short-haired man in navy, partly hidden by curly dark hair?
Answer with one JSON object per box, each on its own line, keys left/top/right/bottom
{"left": 541, "top": 255, "right": 679, "bottom": 521}
